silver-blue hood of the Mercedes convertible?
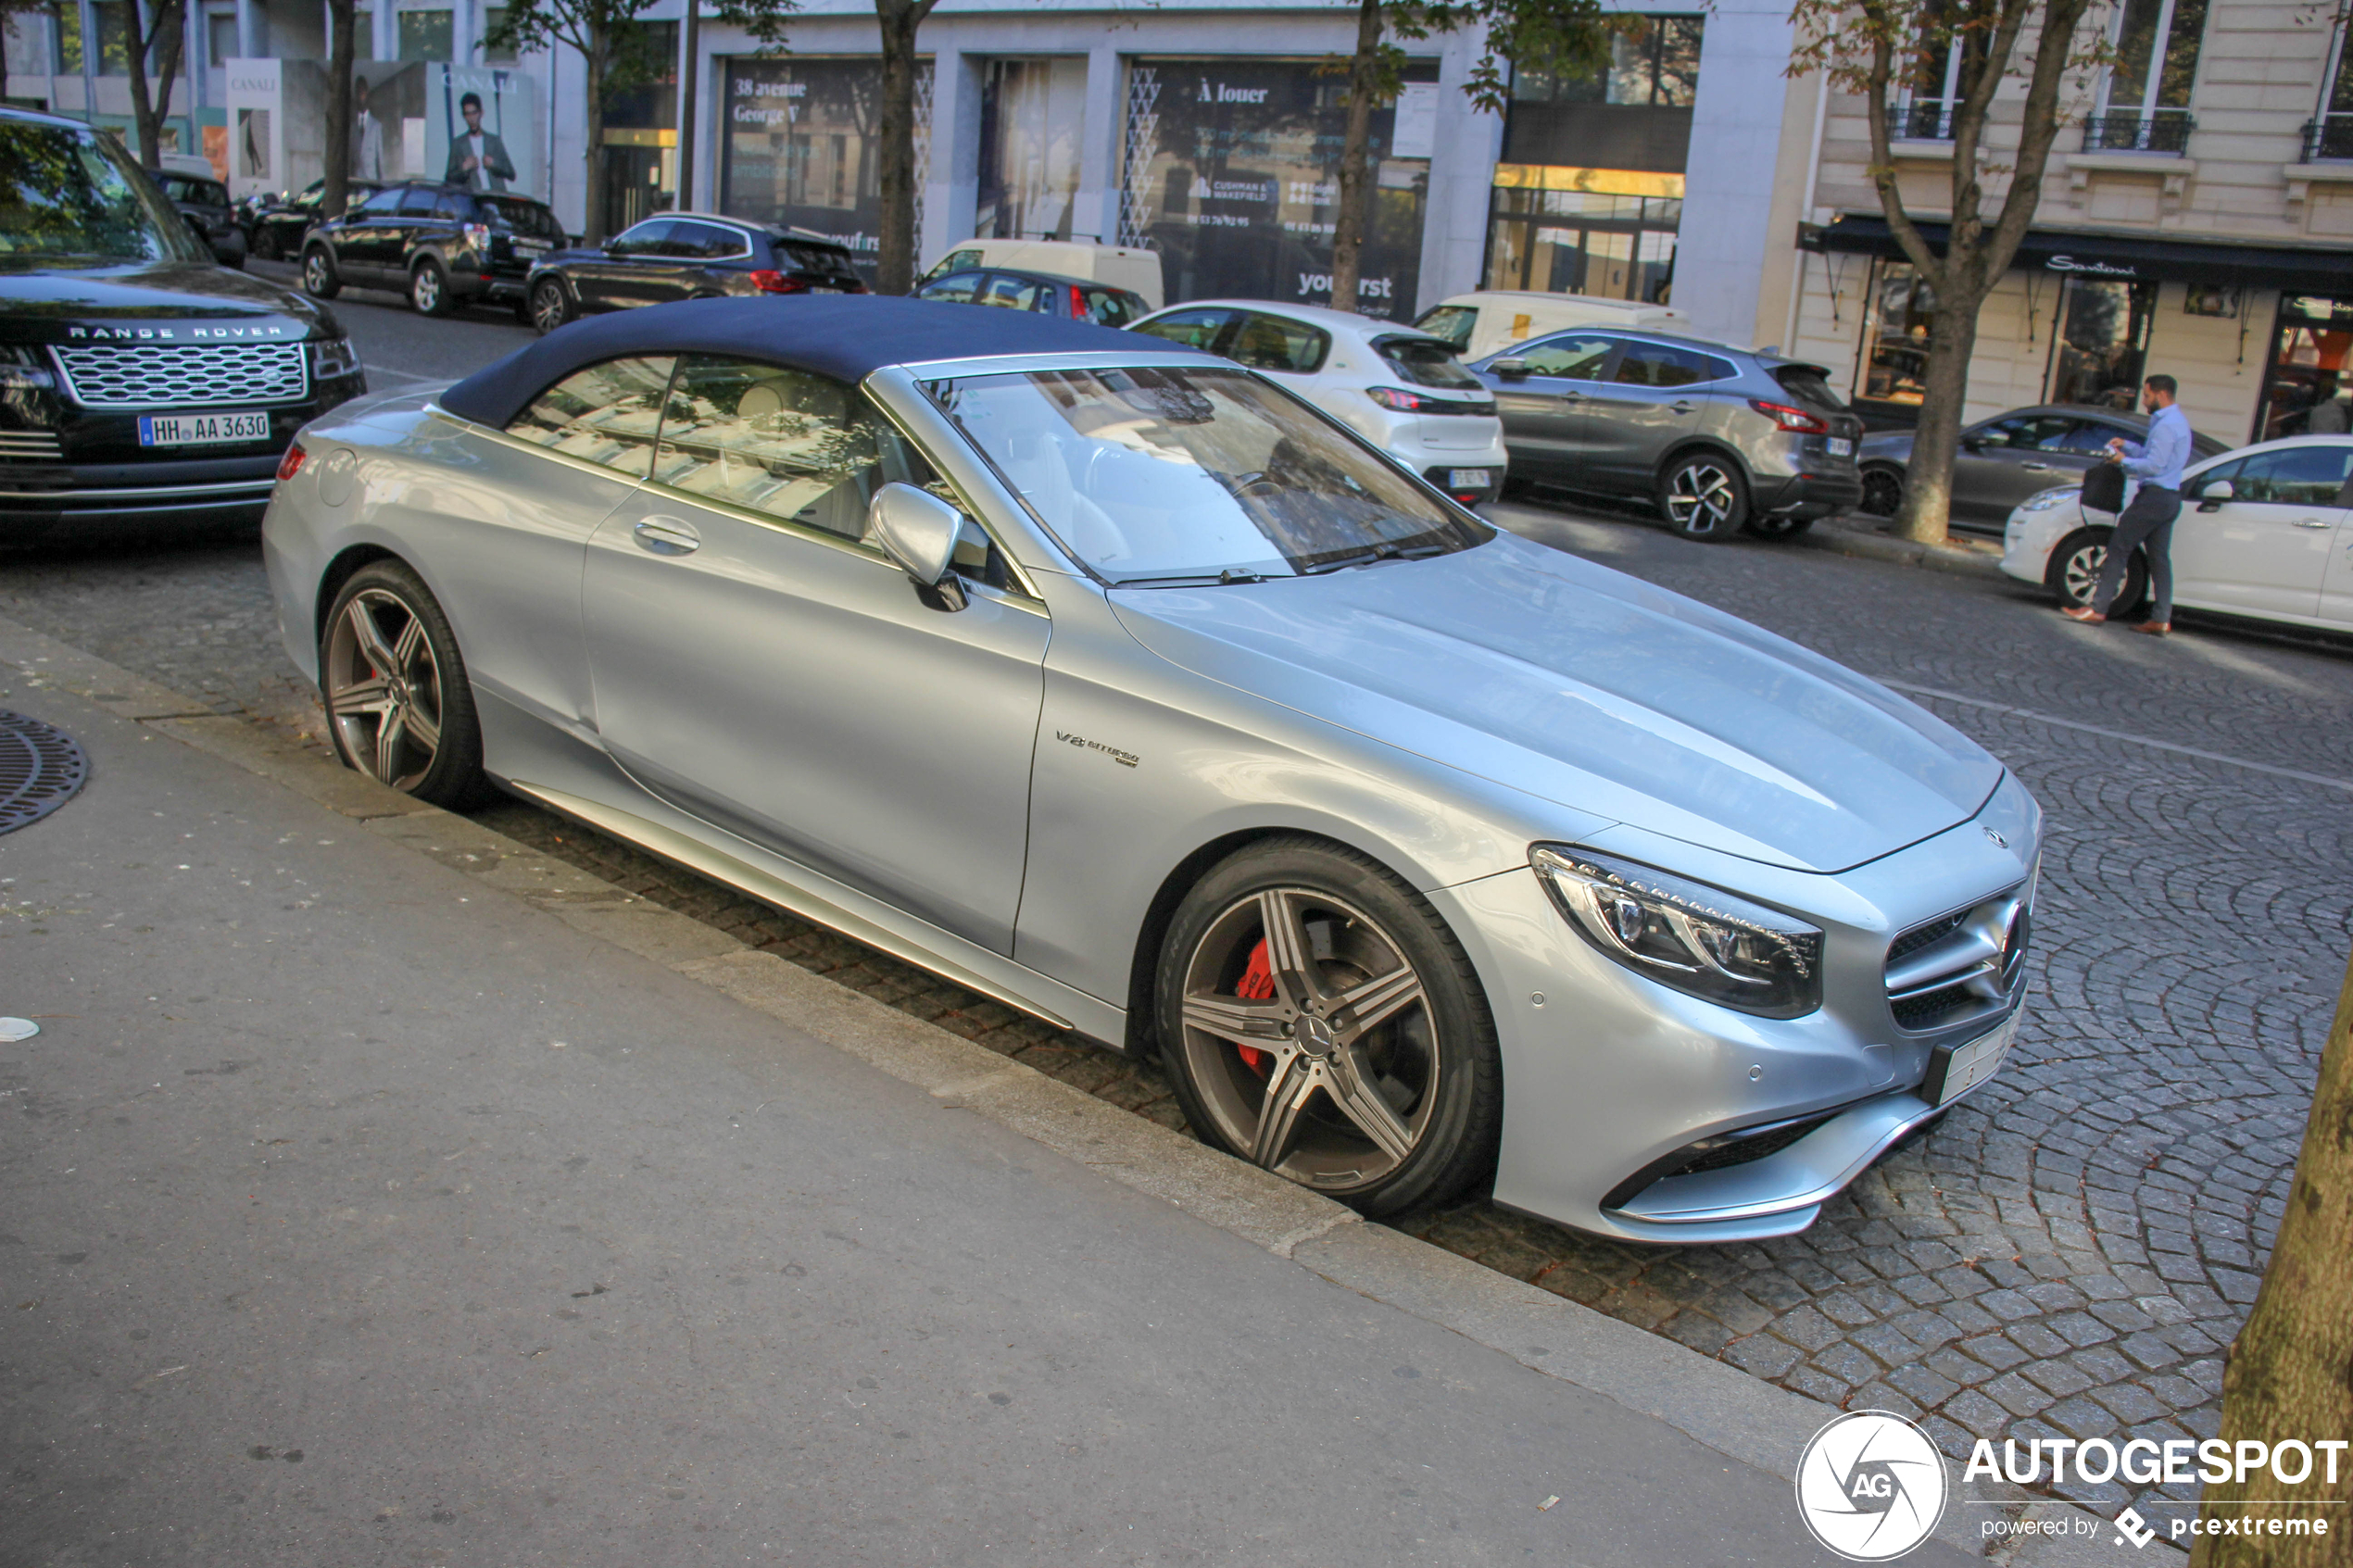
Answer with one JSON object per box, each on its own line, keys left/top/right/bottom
{"left": 1111, "top": 533, "right": 2003, "bottom": 872}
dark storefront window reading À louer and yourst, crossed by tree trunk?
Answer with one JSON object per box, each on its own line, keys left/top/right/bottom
{"left": 1120, "top": 58, "right": 1433, "bottom": 320}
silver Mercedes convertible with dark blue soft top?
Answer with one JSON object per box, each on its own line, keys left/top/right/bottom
{"left": 266, "top": 298, "right": 2040, "bottom": 1241}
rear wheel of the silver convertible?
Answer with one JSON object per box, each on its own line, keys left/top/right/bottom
{"left": 318, "top": 559, "right": 492, "bottom": 811}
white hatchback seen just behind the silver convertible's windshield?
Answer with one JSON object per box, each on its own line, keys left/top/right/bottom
{"left": 1129, "top": 298, "right": 1506, "bottom": 506}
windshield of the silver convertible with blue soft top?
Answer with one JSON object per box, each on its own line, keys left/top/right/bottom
{"left": 929, "top": 367, "right": 1494, "bottom": 585}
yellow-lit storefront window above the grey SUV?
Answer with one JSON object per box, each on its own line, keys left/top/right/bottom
{"left": 1487, "top": 182, "right": 1682, "bottom": 306}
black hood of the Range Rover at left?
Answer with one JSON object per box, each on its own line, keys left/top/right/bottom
{"left": 0, "top": 261, "right": 344, "bottom": 344}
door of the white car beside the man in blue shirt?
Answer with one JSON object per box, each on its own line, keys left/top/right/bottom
{"left": 2171, "top": 442, "right": 2353, "bottom": 621}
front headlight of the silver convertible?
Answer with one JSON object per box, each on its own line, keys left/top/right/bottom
{"left": 1529, "top": 844, "right": 1821, "bottom": 1018}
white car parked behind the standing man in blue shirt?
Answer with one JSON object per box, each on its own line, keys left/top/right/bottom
{"left": 2003, "top": 435, "right": 2353, "bottom": 630}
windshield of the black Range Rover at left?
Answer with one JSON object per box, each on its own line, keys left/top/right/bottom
{"left": 0, "top": 119, "right": 212, "bottom": 261}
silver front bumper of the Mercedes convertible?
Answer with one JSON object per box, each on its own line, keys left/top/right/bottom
{"left": 1430, "top": 778, "right": 2040, "bottom": 1246}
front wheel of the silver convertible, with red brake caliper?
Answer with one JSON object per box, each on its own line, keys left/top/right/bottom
{"left": 1155, "top": 837, "right": 1504, "bottom": 1215}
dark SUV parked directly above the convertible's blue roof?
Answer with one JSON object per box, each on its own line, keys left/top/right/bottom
{"left": 530, "top": 211, "right": 866, "bottom": 332}
